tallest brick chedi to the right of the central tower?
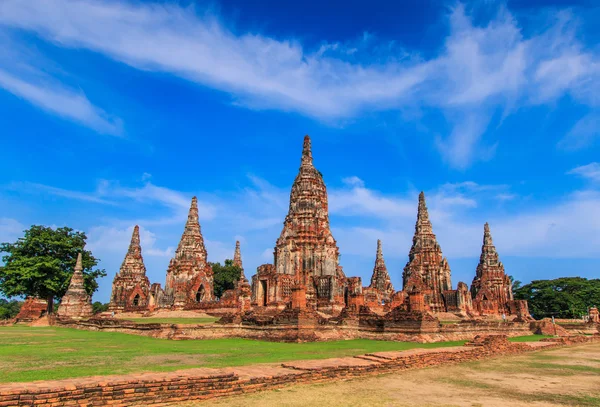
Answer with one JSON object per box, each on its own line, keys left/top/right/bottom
{"left": 402, "top": 192, "right": 452, "bottom": 312}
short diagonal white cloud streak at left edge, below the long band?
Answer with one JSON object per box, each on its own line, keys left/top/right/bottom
{"left": 0, "top": 69, "right": 123, "bottom": 136}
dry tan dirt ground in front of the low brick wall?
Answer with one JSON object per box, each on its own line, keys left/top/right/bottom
{"left": 177, "top": 344, "right": 600, "bottom": 407}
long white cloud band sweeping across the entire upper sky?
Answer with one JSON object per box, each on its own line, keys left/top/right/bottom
{"left": 0, "top": 0, "right": 600, "bottom": 168}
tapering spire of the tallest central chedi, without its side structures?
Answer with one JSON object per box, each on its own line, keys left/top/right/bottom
{"left": 275, "top": 136, "right": 339, "bottom": 279}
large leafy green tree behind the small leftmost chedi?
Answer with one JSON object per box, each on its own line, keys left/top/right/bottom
{"left": 0, "top": 225, "right": 106, "bottom": 313}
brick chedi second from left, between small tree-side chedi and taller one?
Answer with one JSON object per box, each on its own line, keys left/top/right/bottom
{"left": 108, "top": 225, "right": 150, "bottom": 312}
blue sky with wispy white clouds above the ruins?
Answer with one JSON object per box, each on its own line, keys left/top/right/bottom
{"left": 0, "top": 0, "right": 600, "bottom": 301}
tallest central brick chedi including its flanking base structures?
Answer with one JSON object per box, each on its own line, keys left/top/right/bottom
{"left": 252, "top": 136, "right": 347, "bottom": 309}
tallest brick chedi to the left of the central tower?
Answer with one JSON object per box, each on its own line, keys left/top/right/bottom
{"left": 161, "top": 197, "right": 213, "bottom": 309}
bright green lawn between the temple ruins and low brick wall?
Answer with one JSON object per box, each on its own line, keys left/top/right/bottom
{"left": 0, "top": 326, "right": 464, "bottom": 382}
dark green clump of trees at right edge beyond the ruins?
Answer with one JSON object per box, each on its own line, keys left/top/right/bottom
{"left": 514, "top": 277, "right": 600, "bottom": 319}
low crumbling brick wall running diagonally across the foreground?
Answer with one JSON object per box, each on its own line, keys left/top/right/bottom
{"left": 0, "top": 336, "right": 600, "bottom": 407}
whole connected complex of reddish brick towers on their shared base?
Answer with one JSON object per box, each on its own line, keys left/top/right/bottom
{"left": 85, "top": 136, "right": 530, "bottom": 340}
